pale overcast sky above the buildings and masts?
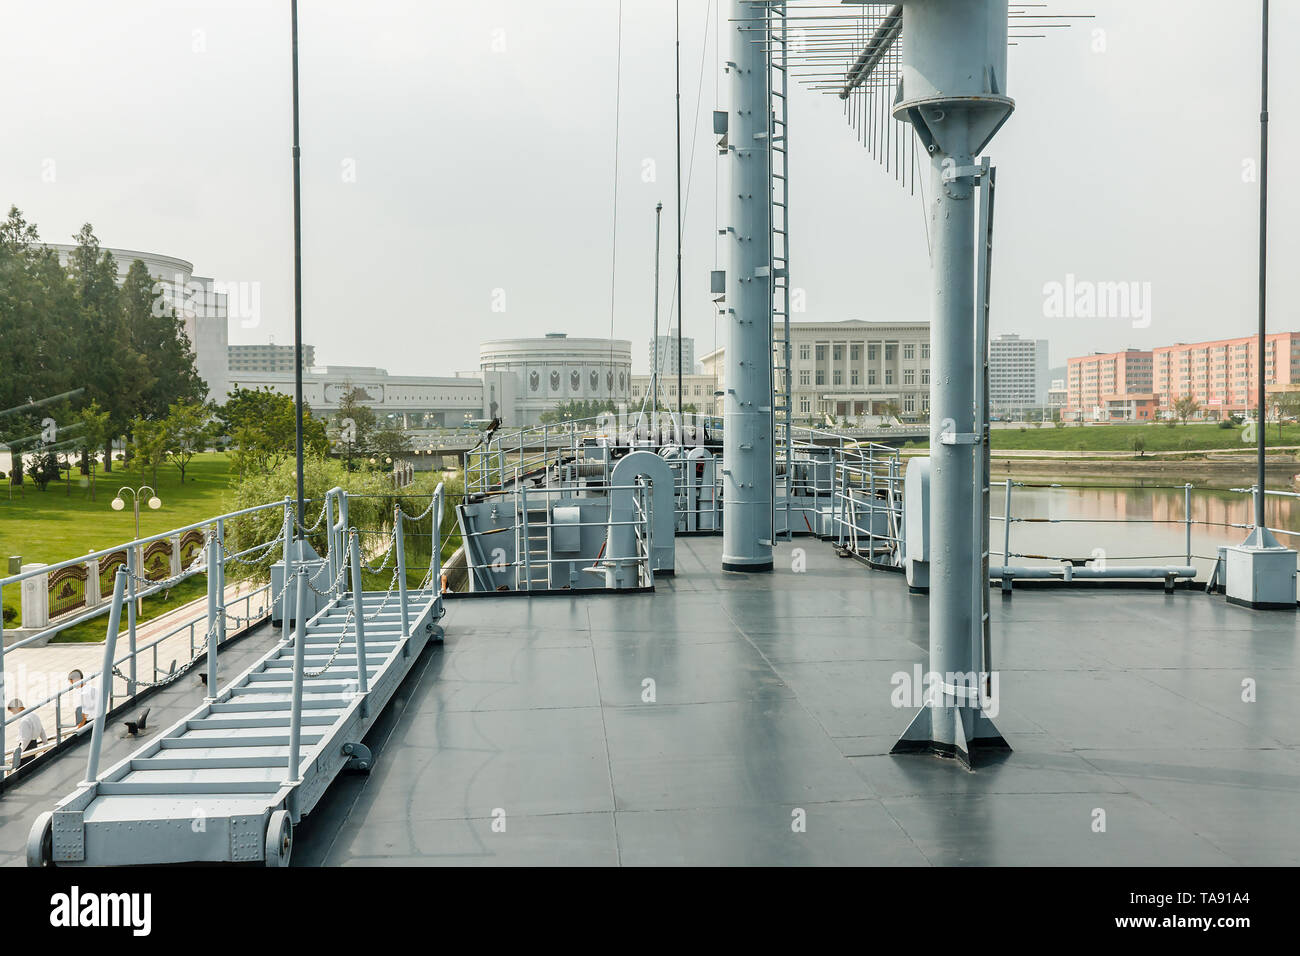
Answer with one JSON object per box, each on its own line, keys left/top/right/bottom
{"left": 0, "top": 0, "right": 1300, "bottom": 375}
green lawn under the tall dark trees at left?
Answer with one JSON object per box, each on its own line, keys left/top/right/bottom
{"left": 0, "top": 453, "right": 230, "bottom": 629}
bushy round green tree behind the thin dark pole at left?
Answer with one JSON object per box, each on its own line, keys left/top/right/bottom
{"left": 217, "top": 388, "right": 329, "bottom": 475}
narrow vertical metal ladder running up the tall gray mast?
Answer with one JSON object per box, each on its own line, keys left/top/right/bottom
{"left": 767, "top": 0, "right": 793, "bottom": 542}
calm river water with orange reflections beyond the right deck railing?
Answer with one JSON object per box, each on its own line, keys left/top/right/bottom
{"left": 989, "top": 483, "right": 1300, "bottom": 581}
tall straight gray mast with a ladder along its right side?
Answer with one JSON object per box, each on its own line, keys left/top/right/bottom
{"left": 722, "top": 0, "right": 772, "bottom": 571}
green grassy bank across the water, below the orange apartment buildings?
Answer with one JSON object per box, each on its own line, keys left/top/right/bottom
{"left": 911, "top": 423, "right": 1300, "bottom": 454}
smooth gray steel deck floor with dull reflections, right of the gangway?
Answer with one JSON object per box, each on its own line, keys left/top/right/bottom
{"left": 289, "top": 537, "right": 1300, "bottom": 865}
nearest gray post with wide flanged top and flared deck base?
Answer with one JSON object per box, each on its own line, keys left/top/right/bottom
{"left": 893, "top": 0, "right": 1015, "bottom": 766}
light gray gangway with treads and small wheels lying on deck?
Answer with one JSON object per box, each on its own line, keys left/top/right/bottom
{"left": 27, "top": 485, "right": 443, "bottom": 866}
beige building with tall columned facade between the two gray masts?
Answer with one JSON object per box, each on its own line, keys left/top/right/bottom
{"left": 701, "top": 319, "right": 930, "bottom": 423}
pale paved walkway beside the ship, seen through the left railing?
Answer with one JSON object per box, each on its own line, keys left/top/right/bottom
{"left": 4, "top": 581, "right": 269, "bottom": 765}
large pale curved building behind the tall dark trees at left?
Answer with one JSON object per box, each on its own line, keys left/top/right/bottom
{"left": 43, "top": 242, "right": 230, "bottom": 403}
